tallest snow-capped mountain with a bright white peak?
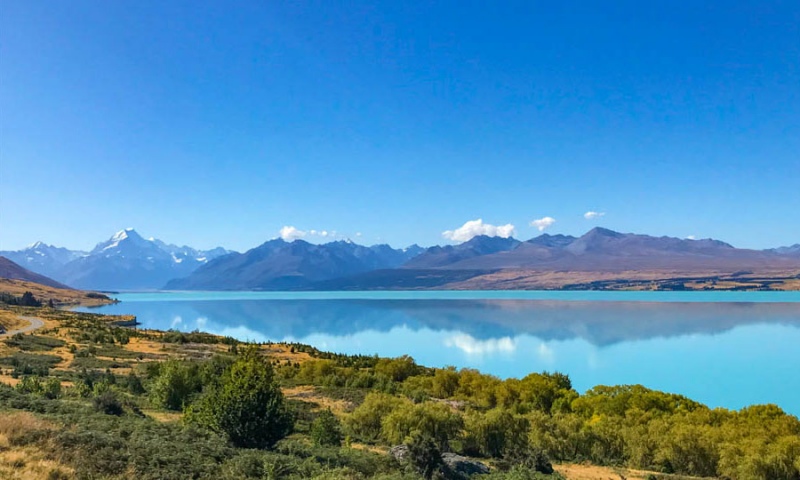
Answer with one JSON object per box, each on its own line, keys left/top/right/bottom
{"left": 54, "top": 228, "right": 230, "bottom": 290}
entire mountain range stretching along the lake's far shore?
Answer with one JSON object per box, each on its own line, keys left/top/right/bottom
{"left": 0, "top": 227, "right": 800, "bottom": 290}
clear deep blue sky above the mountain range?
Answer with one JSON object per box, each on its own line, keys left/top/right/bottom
{"left": 0, "top": 0, "right": 800, "bottom": 250}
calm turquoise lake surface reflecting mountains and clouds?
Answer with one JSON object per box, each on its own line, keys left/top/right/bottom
{"left": 76, "top": 291, "right": 800, "bottom": 415}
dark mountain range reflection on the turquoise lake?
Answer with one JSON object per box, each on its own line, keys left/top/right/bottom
{"left": 98, "top": 299, "right": 800, "bottom": 346}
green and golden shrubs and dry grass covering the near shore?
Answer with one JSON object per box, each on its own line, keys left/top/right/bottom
{"left": 0, "top": 300, "right": 800, "bottom": 480}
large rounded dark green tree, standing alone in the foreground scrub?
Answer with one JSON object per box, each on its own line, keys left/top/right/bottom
{"left": 187, "top": 348, "right": 292, "bottom": 448}
